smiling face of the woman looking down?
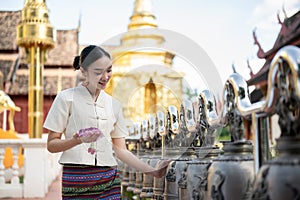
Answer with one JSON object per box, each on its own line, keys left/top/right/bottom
{"left": 85, "top": 56, "right": 112, "bottom": 90}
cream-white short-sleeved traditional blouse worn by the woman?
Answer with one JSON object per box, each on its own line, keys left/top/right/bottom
{"left": 44, "top": 85, "right": 128, "bottom": 166}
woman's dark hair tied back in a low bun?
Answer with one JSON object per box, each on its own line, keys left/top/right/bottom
{"left": 73, "top": 45, "right": 111, "bottom": 70}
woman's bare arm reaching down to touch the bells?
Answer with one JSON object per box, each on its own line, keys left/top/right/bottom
{"left": 112, "top": 138, "right": 170, "bottom": 177}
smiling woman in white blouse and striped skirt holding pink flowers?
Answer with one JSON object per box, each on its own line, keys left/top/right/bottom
{"left": 44, "top": 45, "right": 168, "bottom": 199}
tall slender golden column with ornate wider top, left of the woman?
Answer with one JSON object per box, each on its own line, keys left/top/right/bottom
{"left": 17, "top": 0, "right": 54, "bottom": 138}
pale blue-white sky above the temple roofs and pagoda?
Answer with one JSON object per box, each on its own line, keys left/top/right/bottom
{"left": 0, "top": 0, "right": 300, "bottom": 90}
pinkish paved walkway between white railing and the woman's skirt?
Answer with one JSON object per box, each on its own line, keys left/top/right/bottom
{"left": 0, "top": 175, "right": 61, "bottom": 200}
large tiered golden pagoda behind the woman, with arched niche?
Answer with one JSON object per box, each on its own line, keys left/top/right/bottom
{"left": 106, "top": 0, "right": 182, "bottom": 125}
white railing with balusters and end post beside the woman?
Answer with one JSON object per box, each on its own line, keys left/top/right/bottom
{"left": 0, "top": 138, "right": 61, "bottom": 198}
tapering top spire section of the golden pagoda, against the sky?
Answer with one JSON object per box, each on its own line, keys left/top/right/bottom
{"left": 128, "top": 0, "right": 157, "bottom": 30}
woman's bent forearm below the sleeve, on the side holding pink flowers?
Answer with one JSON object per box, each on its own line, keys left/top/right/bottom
{"left": 47, "top": 131, "right": 82, "bottom": 153}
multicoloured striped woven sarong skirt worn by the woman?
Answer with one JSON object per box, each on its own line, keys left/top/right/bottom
{"left": 62, "top": 165, "right": 121, "bottom": 200}
